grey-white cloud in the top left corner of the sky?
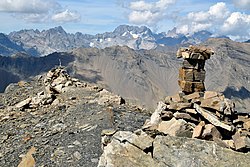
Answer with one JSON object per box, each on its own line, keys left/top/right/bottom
{"left": 0, "top": 0, "right": 81, "bottom": 23}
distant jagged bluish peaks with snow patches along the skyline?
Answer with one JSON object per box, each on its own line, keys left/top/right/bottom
{"left": 0, "top": 25, "right": 228, "bottom": 56}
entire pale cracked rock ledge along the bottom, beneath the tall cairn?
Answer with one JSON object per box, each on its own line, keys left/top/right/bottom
{"left": 98, "top": 132, "right": 250, "bottom": 167}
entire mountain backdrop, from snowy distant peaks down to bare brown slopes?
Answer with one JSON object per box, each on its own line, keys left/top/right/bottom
{"left": 0, "top": 25, "right": 250, "bottom": 111}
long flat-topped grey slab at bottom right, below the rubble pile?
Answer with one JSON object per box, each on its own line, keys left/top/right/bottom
{"left": 153, "top": 136, "right": 250, "bottom": 167}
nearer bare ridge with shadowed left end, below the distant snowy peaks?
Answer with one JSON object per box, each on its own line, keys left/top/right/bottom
{"left": 0, "top": 38, "right": 250, "bottom": 112}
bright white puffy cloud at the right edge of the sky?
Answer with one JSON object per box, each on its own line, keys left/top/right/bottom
{"left": 177, "top": 2, "right": 250, "bottom": 41}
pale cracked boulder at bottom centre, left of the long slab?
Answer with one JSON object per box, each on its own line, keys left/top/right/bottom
{"left": 98, "top": 131, "right": 158, "bottom": 167}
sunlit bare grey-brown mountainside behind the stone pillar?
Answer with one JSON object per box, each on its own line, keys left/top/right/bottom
{"left": 70, "top": 39, "right": 250, "bottom": 111}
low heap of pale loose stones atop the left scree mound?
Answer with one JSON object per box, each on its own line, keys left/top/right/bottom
{"left": 14, "top": 66, "right": 125, "bottom": 110}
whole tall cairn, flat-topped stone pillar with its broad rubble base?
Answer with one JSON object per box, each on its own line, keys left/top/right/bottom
{"left": 142, "top": 46, "right": 250, "bottom": 152}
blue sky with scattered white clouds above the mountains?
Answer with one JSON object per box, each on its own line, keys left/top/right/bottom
{"left": 0, "top": 0, "right": 250, "bottom": 40}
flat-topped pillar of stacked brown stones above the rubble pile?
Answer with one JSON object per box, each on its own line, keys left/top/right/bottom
{"left": 177, "top": 46, "right": 214, "bottom": 94}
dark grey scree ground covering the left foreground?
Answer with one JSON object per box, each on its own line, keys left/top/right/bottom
{"left": 0, "top": 67, "right": 149, "bottom": 167}
